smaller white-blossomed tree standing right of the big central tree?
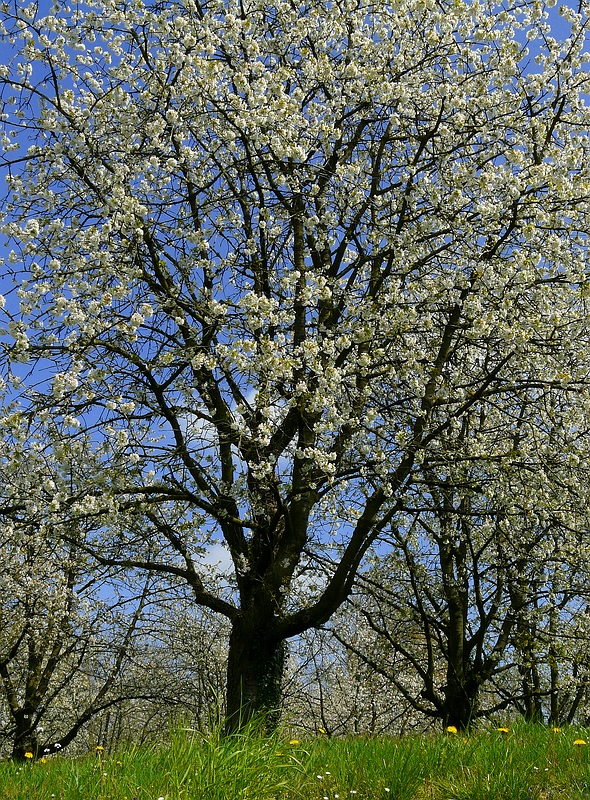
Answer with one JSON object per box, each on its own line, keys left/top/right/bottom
{"left": 334, "top": 387, "right": 590, "bottom": 729}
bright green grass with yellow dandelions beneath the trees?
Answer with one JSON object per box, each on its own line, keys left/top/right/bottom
{"left": 0, "top": 725, "right": 590, "bottom": 800}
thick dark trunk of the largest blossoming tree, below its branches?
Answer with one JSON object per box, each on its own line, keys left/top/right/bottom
{"left": 225, "top": 617, "right": 287, "bottom": 733}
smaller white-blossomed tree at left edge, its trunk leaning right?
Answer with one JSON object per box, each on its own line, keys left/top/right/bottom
{"left": 0, "top": 430, "right": 162, "bottom": 760}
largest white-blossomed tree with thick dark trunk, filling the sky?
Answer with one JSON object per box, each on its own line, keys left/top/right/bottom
{"left": 1, "top": 0, "right": 590, "bottom": 728}
